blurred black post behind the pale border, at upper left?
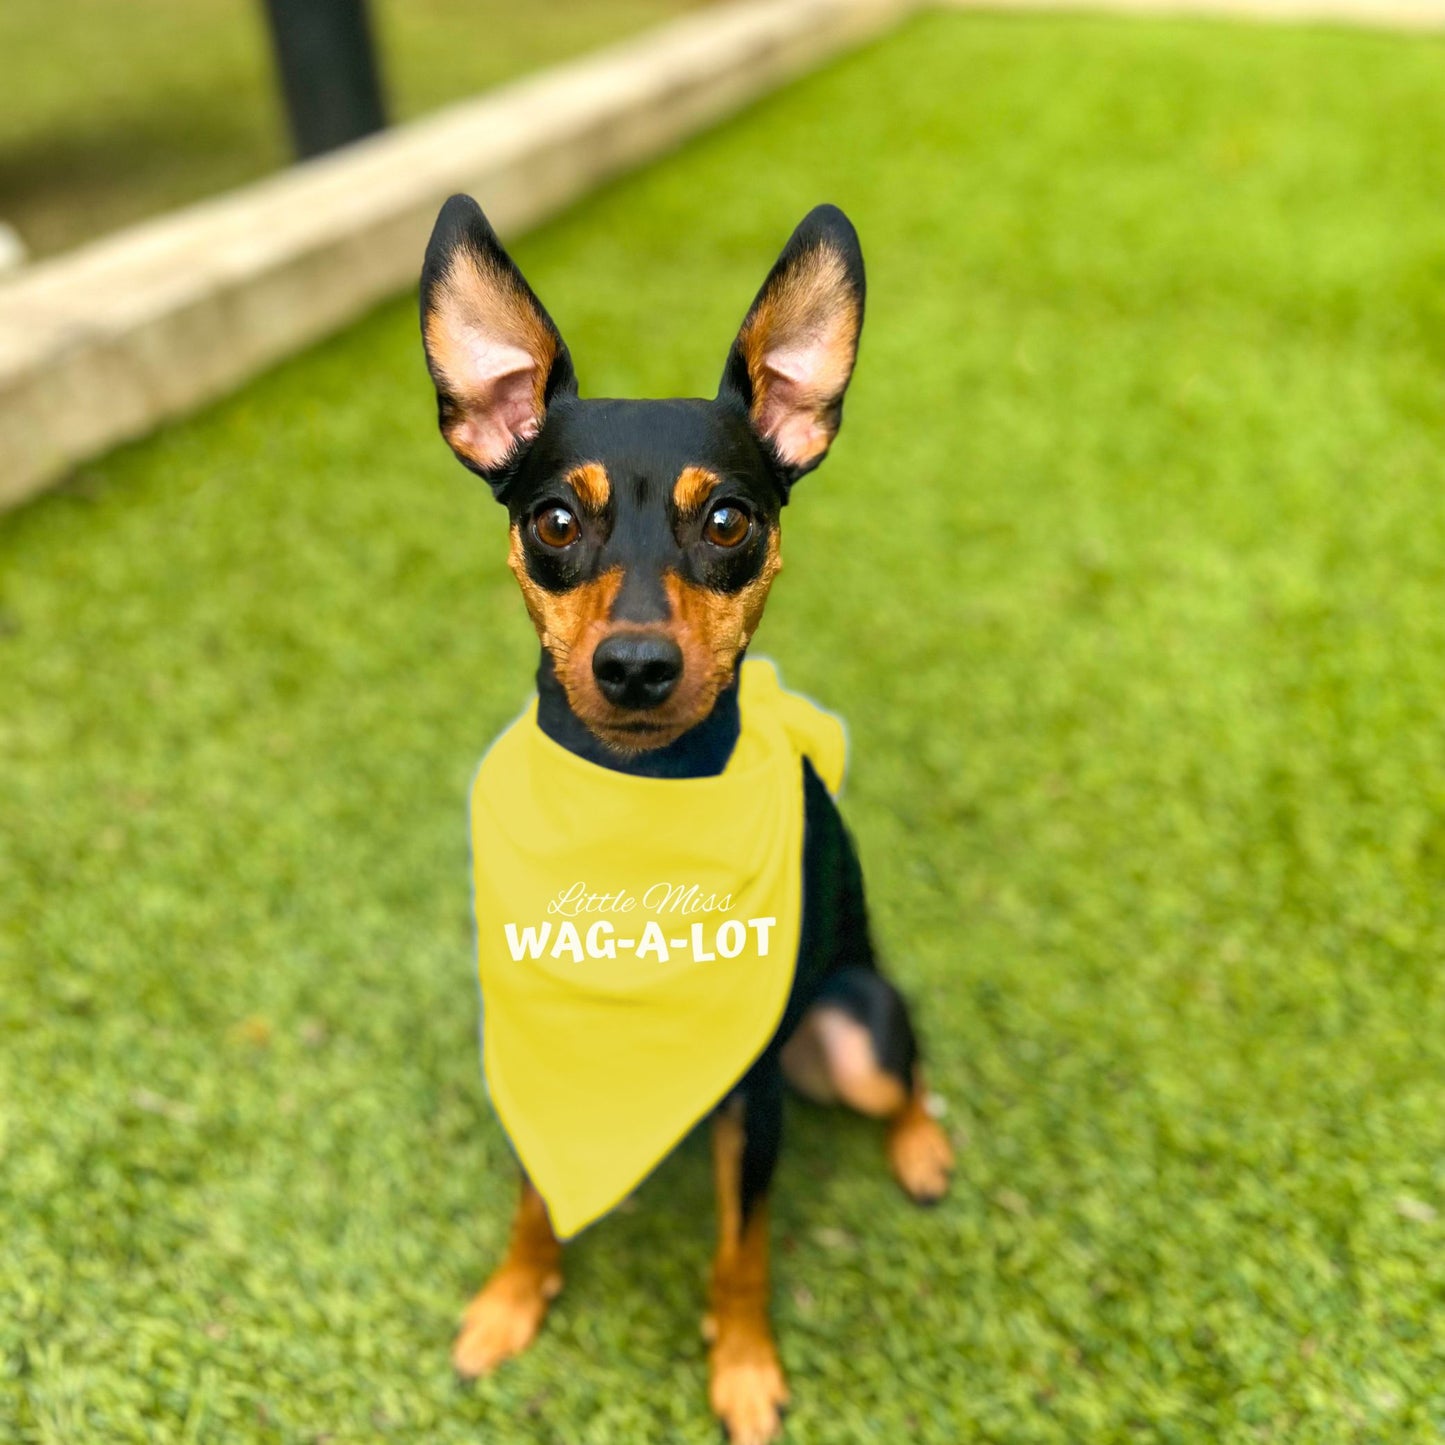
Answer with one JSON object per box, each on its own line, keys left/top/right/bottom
{"left": 266, "top": 0, "right": 386, "bottom": 159}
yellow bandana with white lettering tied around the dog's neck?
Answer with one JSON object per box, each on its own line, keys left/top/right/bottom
{"left": 471, "top": 660, "right": 845, "bottom": 1238}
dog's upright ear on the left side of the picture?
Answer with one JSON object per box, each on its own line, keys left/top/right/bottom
{"left": 422, "top": 195, "right": 577, "bottom": 491}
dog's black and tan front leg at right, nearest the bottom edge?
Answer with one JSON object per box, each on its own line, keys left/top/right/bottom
{"left": 702, "top": 1053, "right": 788, "bottom": 1445}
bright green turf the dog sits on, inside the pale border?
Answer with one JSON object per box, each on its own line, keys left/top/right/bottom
{"left": 0, "top": 16, "right": 1445, "bottom": 1445}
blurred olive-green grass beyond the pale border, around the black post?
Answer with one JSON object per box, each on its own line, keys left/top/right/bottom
{"left": 0, "top": 0, "right": 698, "bottom": 254}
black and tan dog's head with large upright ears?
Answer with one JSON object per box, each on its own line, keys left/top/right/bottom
{"left": 422, "top": 195, "right": 864, "bottom": 751}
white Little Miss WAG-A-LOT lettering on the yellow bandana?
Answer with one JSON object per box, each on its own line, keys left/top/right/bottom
{"left": 503, "top": 883, "right": 777, "bottom": 964}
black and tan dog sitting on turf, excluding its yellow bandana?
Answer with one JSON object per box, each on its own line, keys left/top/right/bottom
{"left": 422, "top": 197, "right": 952, "bottom": 1445}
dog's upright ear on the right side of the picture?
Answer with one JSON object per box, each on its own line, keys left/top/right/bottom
{"left": 718, "top": 205, "right": 864, "bottom": 487}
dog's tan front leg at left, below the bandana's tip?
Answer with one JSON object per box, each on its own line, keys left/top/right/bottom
{"left": 452, "top": 1175, "right": 562, "bottom": 1377}
